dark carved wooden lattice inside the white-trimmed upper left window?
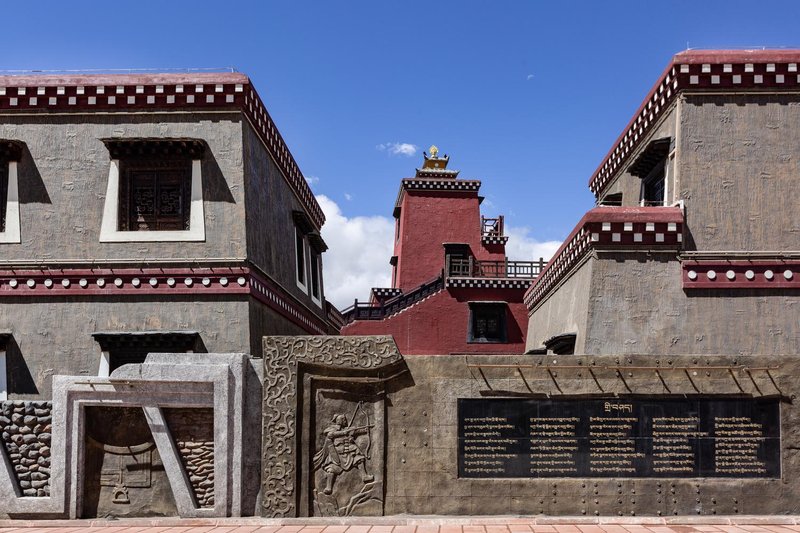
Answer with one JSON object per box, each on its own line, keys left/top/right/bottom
{"left": 118, "top": 158, "right": 192, "bottom": 231}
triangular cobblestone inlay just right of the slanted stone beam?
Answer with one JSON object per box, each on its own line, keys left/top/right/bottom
{"left": 164, "top": 409, "right": 214, "bottom": 508}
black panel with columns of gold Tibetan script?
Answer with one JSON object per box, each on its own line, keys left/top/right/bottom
{"left": 458, "top": 398, "right": 780, "bottom": 478}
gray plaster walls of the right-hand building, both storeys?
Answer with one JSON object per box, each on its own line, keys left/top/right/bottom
{"left": 527, "top": 65, "right": 800, "bottom": 355}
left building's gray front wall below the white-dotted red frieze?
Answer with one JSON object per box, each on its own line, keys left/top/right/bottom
{"left": 0, "top": 296, "right": 250, "bottom": 399}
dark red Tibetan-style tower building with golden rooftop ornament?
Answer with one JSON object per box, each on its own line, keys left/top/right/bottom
{"left": 342, "top": 146, "right": 544, "bottom": 355}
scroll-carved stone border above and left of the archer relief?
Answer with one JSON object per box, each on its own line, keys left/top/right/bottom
{"left": 261, "top": 336, "right": 405, "bottom": 518}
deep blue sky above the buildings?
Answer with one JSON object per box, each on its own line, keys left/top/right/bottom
{"left": 0, "top": 0, "right": 800, "bottom": 304}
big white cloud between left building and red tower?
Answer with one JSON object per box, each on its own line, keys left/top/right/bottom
{"left": 317, "top": 195, "right": 394, "bottom": 309}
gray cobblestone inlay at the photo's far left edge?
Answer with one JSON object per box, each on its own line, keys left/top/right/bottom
{"left": 0, "top": 400, "right": 53, "bottom": 497}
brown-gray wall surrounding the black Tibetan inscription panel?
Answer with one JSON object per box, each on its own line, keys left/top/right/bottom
{"left": 385, "top": 354, "right": 800, "bottom": 516}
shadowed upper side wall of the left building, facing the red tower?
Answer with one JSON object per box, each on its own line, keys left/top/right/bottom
{"left": 242, "top": 122, "right": 325, "bottom": 316}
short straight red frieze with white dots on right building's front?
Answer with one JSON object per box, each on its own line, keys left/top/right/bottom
{"left": 681, "top": 259, "right": 800, "bottom": 290}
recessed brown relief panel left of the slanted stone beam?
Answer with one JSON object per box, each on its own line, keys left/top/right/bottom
{"left": 82, "top": 407, "right": 177, "bottom": 518}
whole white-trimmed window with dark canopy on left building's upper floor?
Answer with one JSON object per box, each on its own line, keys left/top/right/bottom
{"left": 100, "top": 139, "right": 205, "bottom": 242}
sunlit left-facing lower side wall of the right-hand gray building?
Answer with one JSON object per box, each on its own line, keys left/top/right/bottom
{"left": 525, "top": 260, "right": 593, "bottom": 353}
